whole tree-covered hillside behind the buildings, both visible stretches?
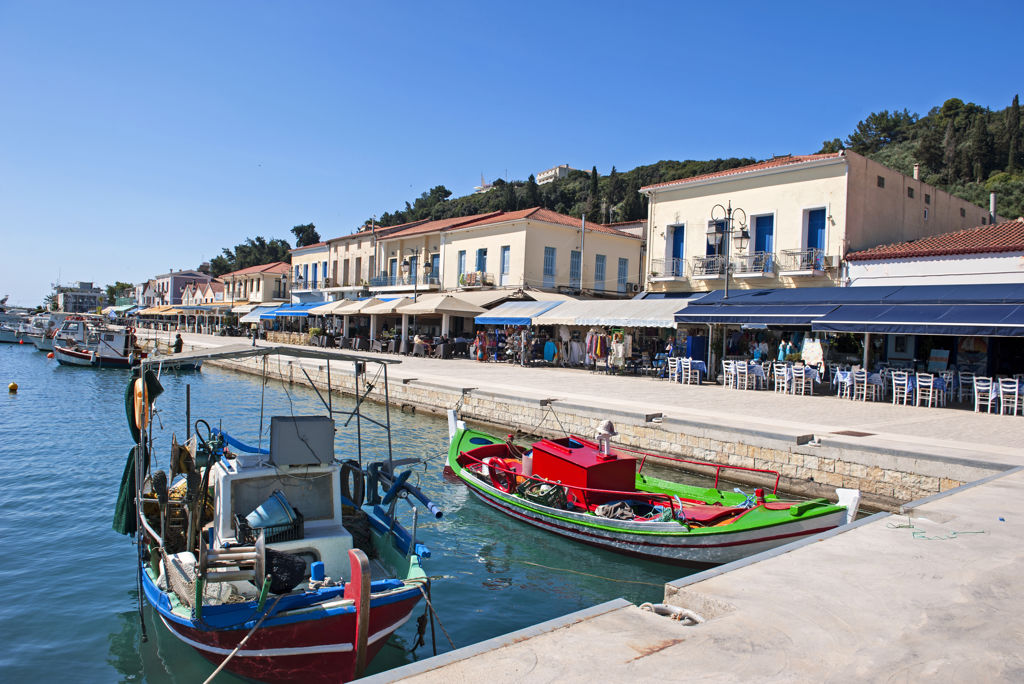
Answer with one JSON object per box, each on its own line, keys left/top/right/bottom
{"left": 367, "top": 96, "right": 1024, "bottom": 231}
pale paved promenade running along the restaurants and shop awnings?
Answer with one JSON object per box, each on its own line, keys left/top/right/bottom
{"left": 157, "top": 331, "right": 1024, "bottom": 467}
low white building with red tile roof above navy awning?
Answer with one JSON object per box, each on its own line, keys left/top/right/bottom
{"left": 846, "top": 218, "right": 1024, "bottom": 287}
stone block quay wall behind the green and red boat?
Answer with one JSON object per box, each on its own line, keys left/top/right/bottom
{"left": 209, "top": 358, "right": 997, "bottom": 510}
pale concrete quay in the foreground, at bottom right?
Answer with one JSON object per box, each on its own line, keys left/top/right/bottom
{"left": 366, "top": 470, "right": 1024, "bottom": 684}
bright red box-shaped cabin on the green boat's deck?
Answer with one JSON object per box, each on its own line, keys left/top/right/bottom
{"left": 534, "top": 435, "right": 636, "bottom": 506}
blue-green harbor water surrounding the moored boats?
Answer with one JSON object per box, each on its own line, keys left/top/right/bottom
{"left": 0, "top": 344, "right": 688, "bottom": 682}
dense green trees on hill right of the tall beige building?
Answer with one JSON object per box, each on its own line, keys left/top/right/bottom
{"left": 820, "top": 95, "right": 1024, "bottom": 218}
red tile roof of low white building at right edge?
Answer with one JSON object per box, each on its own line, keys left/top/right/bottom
{"left": 846, "top": 218, "right": 1024, "bottom": 261}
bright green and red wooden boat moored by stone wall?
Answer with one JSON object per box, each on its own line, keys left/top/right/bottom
{"left": 447, "top": 413, "right": 860, "bottom": 565}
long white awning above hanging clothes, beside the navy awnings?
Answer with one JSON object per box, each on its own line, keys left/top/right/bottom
{"left": 532, "top": 299, "right": 687, "bottom": 328}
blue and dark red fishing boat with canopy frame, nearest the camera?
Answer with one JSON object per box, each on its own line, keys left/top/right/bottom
{"left": 115, "top": 345, "right": 441, "bottom": 682}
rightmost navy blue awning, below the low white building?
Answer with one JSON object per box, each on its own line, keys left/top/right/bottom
{"left": 812, "top": 303, "right": 1024, "bottom": 337}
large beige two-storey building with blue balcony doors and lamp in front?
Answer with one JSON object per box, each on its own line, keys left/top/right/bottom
{"left": 641, "top": 151, "right": 989, "bottom": 292}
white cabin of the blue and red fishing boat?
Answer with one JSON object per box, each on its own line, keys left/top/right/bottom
{"left": 211, "top": 416, "right": 353, "bottom": 581}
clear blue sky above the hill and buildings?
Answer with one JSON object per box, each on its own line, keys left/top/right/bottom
{"left": 0, "top": 0, "right": 1024, "bottom": 304}
